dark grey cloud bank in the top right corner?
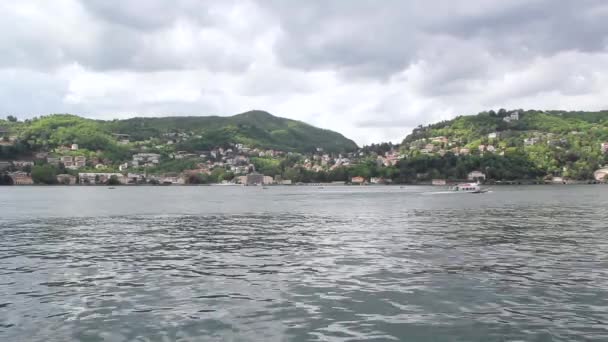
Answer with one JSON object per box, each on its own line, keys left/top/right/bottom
{"left": 434, "top": 0, "right": 608, "bottom": 55}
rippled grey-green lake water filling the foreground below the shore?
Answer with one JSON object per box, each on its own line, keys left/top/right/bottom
{"left": 0, "top": 186, "right": 608, "bottom": 341}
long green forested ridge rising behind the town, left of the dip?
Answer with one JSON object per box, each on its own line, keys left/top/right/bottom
{"left": 0, "top": 111, "right": 357, "bottom": 152}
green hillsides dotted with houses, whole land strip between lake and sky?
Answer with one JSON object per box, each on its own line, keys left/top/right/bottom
{"left": 0, "top": 109, "right": 608, "bottom": 185}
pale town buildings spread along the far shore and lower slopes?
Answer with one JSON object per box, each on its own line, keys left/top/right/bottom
{"left": 0, "top": 133, "right": 608, "bottom": 186}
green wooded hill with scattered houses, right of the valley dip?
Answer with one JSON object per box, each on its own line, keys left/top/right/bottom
{"left": 402, "top": 109, "right": 608, "bottom": 179}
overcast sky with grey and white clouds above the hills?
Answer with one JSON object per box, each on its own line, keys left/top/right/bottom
{"left": 0, "top": 0, "right": 608, "bottom": 145}
